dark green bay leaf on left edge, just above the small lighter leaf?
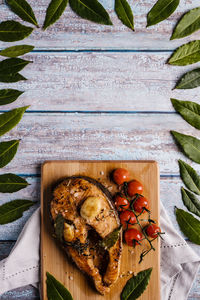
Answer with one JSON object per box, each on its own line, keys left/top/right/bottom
{"left": 0, "top": 21, "right": 33, "bottom": 42}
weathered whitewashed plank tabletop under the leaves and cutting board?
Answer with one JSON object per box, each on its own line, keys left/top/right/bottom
{"left": 0, "top": 0, "right": 200, "bottom": 300}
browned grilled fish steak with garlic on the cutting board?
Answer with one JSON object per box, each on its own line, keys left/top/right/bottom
{"left": 50, "top": 176, "right": 122, "bottom": 295}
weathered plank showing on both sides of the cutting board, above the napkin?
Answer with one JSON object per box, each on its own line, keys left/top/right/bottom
{"left": 0, "top": 177, "right": 199, "bottom": 240}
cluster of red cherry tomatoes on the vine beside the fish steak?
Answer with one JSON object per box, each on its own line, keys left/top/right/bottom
{"left": 112, "top": 168, "right": 163, "bottom": 262}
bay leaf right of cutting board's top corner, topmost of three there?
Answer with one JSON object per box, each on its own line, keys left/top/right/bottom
{"left": 178, "top": 159, "right": 200, "bottom": 195}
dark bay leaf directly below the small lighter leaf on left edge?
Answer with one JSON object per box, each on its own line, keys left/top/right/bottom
{"left": 0, "top": 58, "right": 31, "bottom": 76}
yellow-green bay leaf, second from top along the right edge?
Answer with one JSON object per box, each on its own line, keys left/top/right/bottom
{"left": 168, "top": 40, "right": 200, "bottom": 66}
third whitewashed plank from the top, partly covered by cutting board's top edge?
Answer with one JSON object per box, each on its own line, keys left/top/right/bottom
{"left": 0, "top": 113, "right": 200, "bottom": 174}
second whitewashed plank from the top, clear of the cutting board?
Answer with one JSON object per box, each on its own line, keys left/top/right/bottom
{"left": 0, "top": 52, "right": 200, "bottom": 111}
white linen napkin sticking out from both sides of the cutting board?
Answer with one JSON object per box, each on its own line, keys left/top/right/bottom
{"left": 0, "top": 205, "right": 200, "bottom": 300}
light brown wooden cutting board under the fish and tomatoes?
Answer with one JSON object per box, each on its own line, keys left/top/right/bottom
{"left": 41, "top": 161, "right": 160, "bottom": 300}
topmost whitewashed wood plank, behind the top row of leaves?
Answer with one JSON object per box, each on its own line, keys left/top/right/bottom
{"left": 0, "top": 0, "right": 199, "bottom": 50}
